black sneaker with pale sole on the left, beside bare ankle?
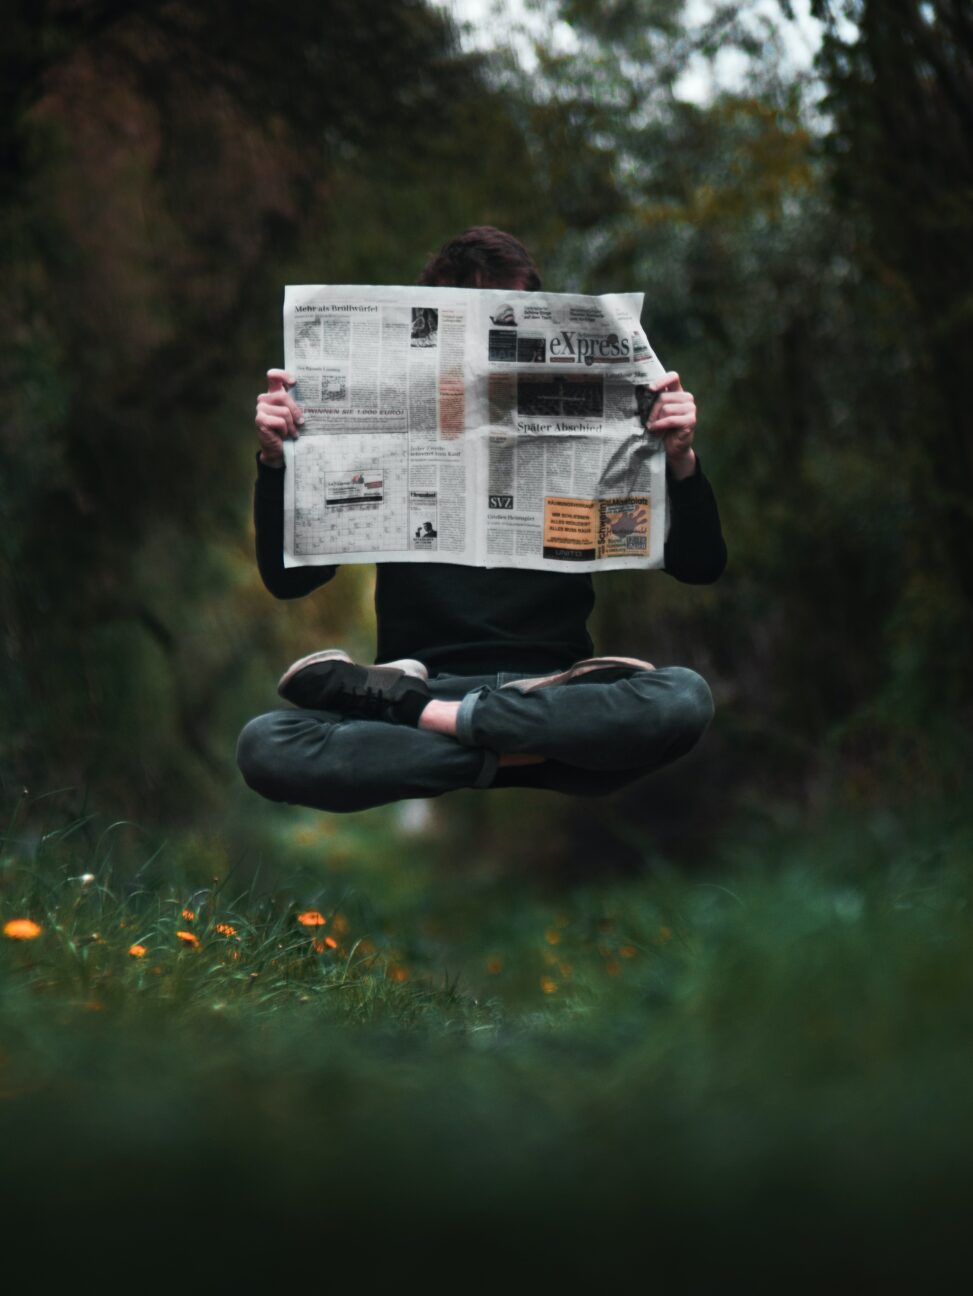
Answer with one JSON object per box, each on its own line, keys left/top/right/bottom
{"left": 277, "top": 648, "right": 433, "bottom": 724}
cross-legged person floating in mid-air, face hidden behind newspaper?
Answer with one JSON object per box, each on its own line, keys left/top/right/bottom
{"left": 237, "top": 226, "right": 727, "bottom": 813}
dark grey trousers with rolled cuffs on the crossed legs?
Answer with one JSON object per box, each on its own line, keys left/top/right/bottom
{"left": 237, "top": 666, "right": 713, "bottom": 813}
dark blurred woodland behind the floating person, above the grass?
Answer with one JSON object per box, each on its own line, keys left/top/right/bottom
{"left": 0, "top": 0, "right": 973, "bottom": 871}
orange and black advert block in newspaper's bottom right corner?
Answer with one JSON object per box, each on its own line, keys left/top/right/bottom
{"left": 544, "top": 495, "right": 650, "bottom": 562}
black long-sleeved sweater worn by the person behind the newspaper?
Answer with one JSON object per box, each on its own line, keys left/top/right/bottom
{"left": 254, "top": 454, "right": 727, "bottom": 675}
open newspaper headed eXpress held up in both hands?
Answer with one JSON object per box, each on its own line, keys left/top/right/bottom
{"left": 284, "top": 285, "right": 667, "bottom": 572}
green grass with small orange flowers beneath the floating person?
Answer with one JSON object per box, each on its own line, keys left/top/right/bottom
{"left": 0, "top": 793, "right": 973, "bottom": 1291}
